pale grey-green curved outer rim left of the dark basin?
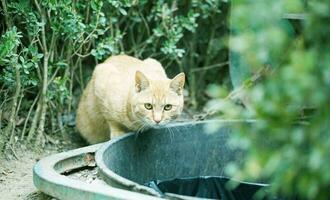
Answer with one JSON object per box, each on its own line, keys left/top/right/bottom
{"left": 33, "top": 143, "right": 160, "bottom": 200}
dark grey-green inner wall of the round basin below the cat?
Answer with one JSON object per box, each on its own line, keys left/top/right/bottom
{"left": 103, "top": 122, "right": 243, "bottom": 184}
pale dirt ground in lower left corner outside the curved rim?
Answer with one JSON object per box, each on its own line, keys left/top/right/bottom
{"left": 0, "top": 130, "right": 87, "bottom": 200}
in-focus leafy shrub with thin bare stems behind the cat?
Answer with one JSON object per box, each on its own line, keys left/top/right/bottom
{"left": 0, "top": 0, "right": 228, "bottom": 149}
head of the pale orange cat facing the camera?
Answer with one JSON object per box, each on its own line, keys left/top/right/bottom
{"left": 131, "top": 71, "right": 185, "bottom": 127}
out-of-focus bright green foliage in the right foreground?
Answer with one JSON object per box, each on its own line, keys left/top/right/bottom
{"left": 208, "top": 0, "right": 330, "bottom": 199}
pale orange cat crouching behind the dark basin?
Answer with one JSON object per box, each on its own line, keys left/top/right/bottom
{"left": 76, "top": 55, "right": 185, "bottom": 144}
